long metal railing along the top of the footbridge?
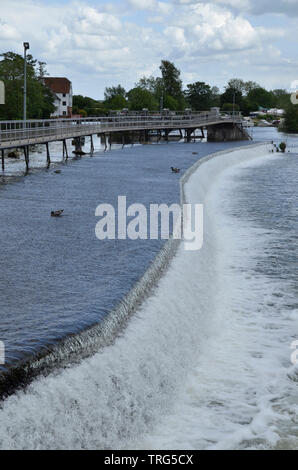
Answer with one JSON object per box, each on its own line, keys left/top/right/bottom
{"left": 0, "top": 111, "right": 242, "bottom": 146}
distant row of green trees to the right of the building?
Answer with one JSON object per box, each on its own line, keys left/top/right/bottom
{"left": 74, "top": 60, "right": 290, "bottom": 115}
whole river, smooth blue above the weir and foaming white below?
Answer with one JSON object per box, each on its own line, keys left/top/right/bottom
{"left": 0, "top": 128, "right": 298, "bottom": 449}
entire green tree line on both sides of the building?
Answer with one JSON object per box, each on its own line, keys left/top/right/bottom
{"left": 0, "top": 52, "right": 298, "bottom": 132}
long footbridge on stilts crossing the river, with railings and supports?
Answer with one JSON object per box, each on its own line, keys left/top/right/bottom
{"left": 0, "top": 111, "right": 249, "bottom": 170}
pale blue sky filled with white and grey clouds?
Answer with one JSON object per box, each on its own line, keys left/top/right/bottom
{"left": 0, "top": 0, "right": 298, "bottom": 99}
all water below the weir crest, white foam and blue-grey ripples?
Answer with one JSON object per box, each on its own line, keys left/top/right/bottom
{"left": 0, "top": 131, "right": 298, "bottom": 449}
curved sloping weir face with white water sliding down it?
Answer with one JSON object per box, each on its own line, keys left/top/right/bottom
{"left": 0, "top": 146, "right": 269, "bottom": 448}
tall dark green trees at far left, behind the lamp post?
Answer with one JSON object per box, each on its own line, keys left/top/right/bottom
{"left": 0, "top": 52, "right": 55, "bottom": 119}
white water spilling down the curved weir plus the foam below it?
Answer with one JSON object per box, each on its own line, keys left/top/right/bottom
{"left": 0, "top": 146, "right": 297, "bottom": 448}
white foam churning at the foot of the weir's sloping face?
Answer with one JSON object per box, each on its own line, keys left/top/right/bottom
{"left": 137, "top": 148, "right": 298, "bottom": 449}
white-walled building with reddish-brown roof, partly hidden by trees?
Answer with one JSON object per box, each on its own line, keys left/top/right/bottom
{"left": 44, "top": 77, "right": 72, "bottom": 118}
